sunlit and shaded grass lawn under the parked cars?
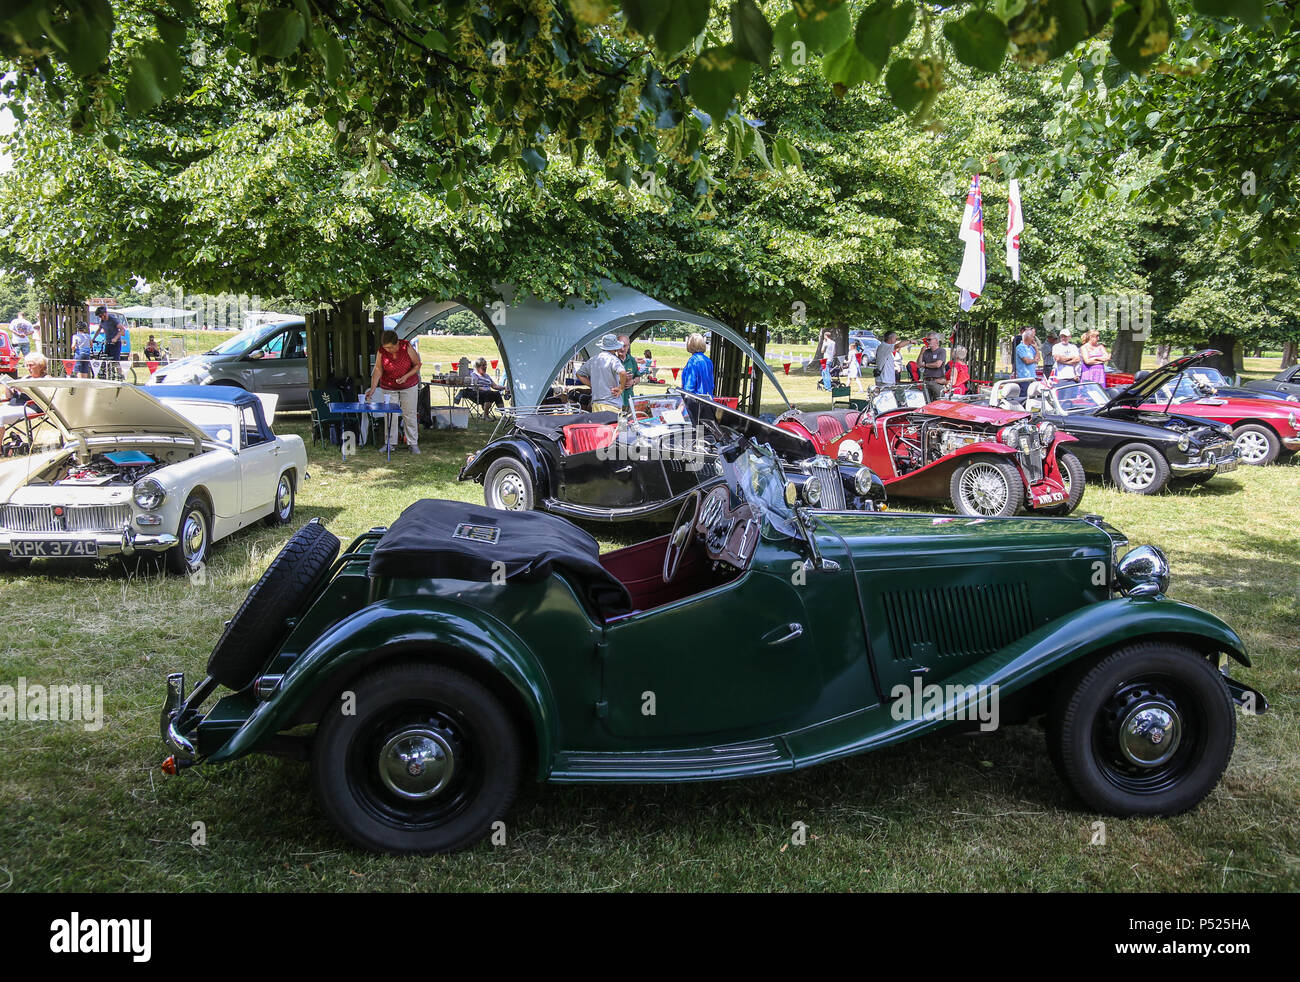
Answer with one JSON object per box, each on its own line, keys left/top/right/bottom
{"left": 0, "top": 348, "right": 1300, "bottom": 892}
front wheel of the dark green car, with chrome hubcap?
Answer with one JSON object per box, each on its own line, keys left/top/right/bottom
{"left": 1048, "top": 641, "right": 1236, "bottom": 816}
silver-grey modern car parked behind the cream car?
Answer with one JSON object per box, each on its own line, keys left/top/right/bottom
{"left": 148, "top": 317, "right": 309, "bottom": 410}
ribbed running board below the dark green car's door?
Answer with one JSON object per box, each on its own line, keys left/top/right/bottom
{"left": 549, "top": 740, "right": 794, "bottom": 784}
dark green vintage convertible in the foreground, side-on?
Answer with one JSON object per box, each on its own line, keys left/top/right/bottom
{"left": 161, "top": 437, "right": 1265, "bottom": 852}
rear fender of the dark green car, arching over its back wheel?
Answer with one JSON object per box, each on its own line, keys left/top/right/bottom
{"left": 208, "top": 597, "right": 558, "bottom": 779}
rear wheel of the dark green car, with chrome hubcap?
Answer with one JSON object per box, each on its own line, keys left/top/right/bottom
{"left": 312, "top": 662, "right": 521, "bottom": 853}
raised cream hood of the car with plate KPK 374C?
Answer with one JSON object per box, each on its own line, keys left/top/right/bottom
{"left": 13, "top": 378, "right": 208, "bottom": 442}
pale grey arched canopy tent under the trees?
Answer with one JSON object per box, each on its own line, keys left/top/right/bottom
{"left": 394, "top": 280, "right": 790, "bottom": 406}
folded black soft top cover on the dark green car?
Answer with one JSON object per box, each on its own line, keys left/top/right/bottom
{"left": 369, "top": 498, "right": 632, "bottom": 618}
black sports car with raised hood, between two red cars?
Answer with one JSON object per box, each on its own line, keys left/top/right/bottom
{"left": 988, "top": 378, "right": 1238, "bottom": 494}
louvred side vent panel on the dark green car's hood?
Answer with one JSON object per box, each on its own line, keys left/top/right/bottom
{"left": 881, "top": 583, "right": 1034, "bottom": 659}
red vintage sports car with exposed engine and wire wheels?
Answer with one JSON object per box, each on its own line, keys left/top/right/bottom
{"left": 776, "top": 388, "right": 1084, "bottom": 518}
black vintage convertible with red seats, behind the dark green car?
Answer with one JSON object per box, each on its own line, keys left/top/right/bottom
{"left": 460, "top": 391, "right": 885, "bottom": 522}
